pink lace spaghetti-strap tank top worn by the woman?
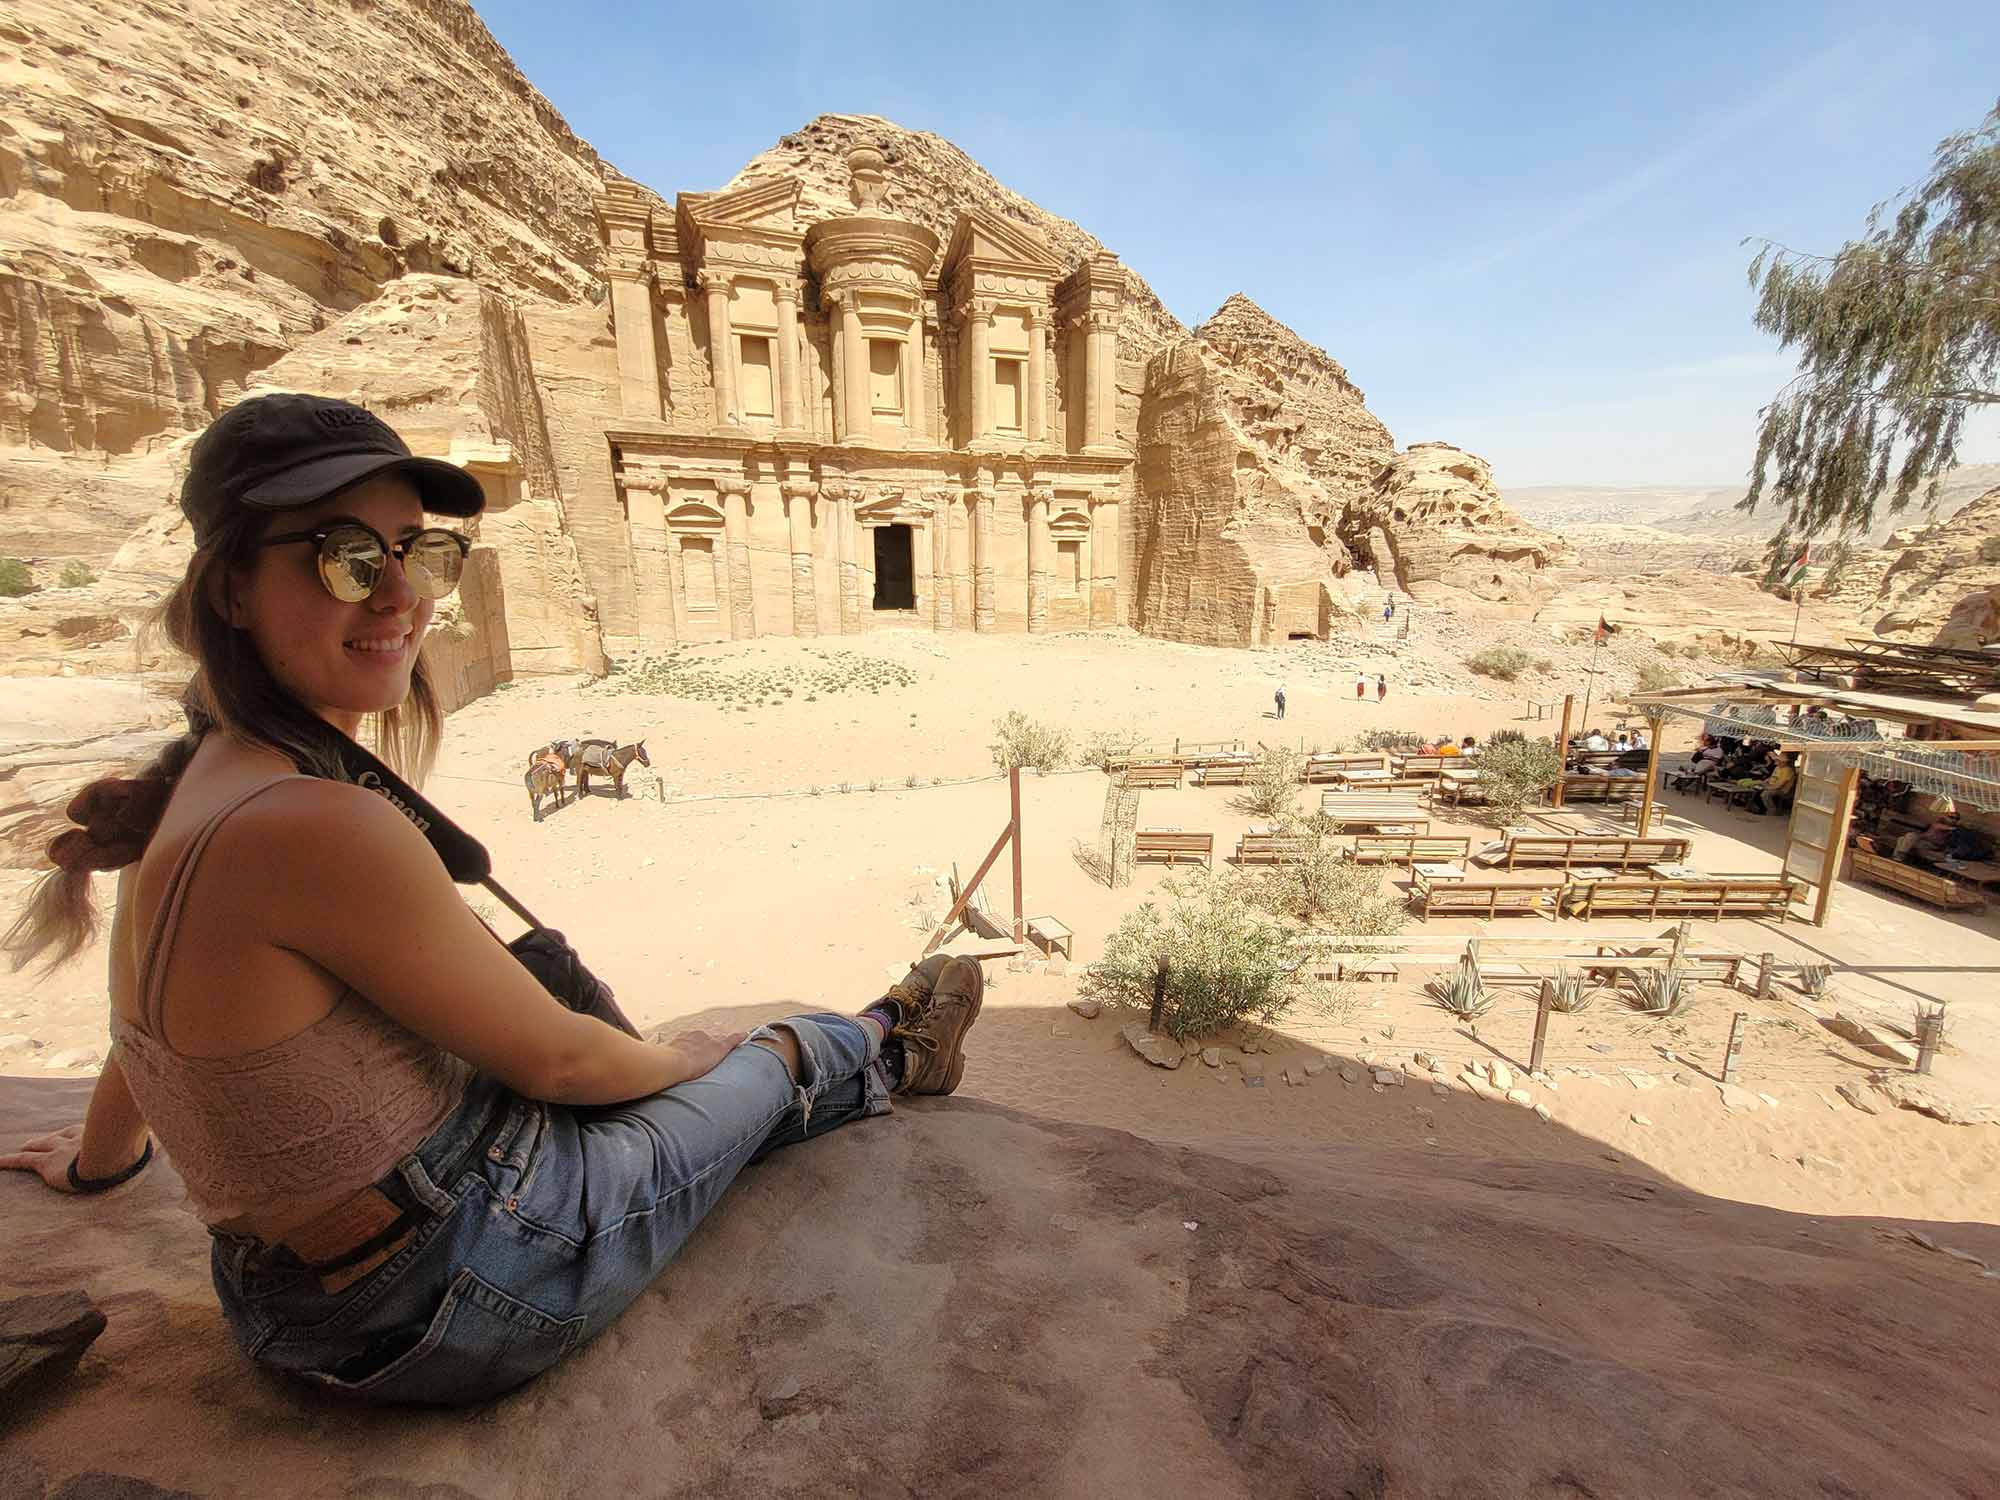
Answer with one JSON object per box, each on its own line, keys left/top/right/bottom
{"left": 112, "top": 778, "right": 470, "bottom": 1240}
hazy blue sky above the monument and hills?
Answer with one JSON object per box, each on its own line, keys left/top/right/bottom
{"left": 474, "top": 0, "right": 2000, "bottom": 486}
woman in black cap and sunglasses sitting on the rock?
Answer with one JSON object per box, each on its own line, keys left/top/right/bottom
{"left": 0, "top": 396, "right": 982, "bottom": 1402}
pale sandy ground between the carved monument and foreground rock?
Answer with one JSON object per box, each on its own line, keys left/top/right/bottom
{"left": 0, "top": 632, "right": 2000, "bottom": 1220}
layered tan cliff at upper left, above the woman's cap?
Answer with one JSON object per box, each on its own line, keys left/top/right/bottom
{"left": 0, "top": 0, "right": 600, "bottom": 560}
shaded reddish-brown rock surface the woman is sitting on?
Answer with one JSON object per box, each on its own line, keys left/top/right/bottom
{"left": 0, "top": 1080, "right": 2000, "bottom": 1500}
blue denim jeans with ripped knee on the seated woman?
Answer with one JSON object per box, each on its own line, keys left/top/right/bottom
{"left": 210, "top": 1014, "right": 890, "bottom": 1404}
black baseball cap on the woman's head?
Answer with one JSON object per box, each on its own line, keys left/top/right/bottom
{"left": 180, "top": 394, "right": 486, "bottom": 546}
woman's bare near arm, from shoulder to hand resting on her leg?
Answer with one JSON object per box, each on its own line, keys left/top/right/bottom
{"left": 229, "top": 780, "right": 742, "bottom": 1104}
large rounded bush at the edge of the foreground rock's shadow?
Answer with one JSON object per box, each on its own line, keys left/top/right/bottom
{"left": 1080, "top": 870, "right": 1306, "bottom": 1038}
